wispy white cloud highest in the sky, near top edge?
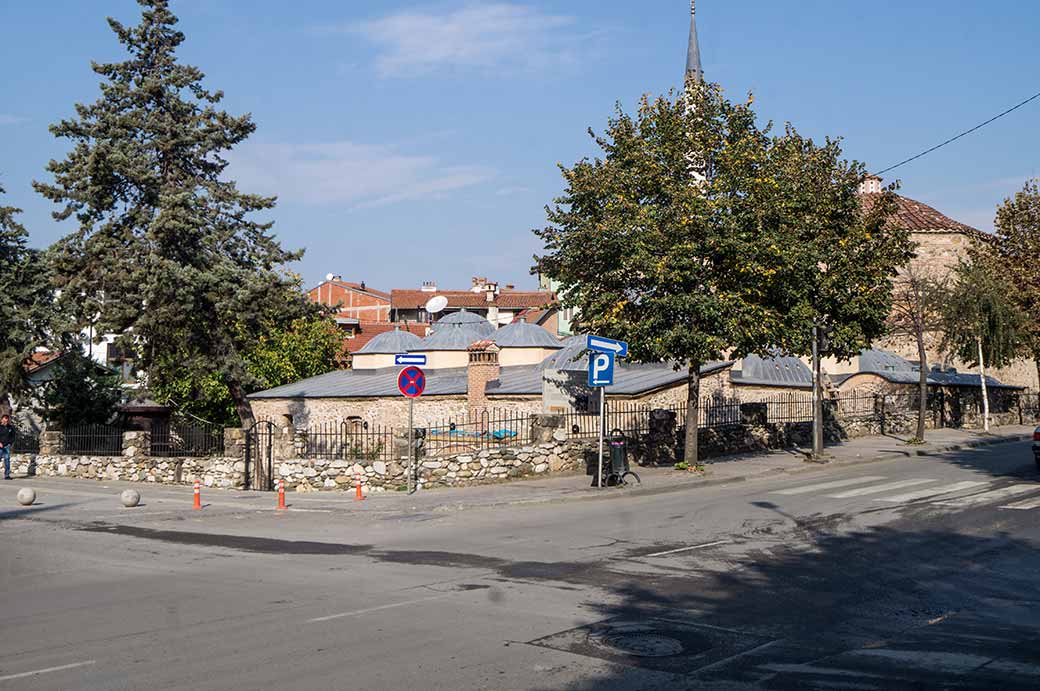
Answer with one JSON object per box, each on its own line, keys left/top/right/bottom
{"left": 348, "top": 2, "right": 576, "bottom": 77}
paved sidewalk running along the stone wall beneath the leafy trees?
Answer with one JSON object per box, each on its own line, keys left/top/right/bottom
{"left": 347, "top": 426, "right": 1034, "bottom": 511}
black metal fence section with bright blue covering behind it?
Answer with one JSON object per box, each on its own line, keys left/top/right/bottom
{"left": 423, "top": 409, "right": 534, "bottom": 456}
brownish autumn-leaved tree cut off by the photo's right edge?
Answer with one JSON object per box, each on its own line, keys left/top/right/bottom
{"left": 994, "top": 179, "right": 1040, "bottom": 376}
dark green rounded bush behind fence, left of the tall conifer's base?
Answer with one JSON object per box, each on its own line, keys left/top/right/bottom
{"left": 35, "top": 350, "right": 122, "bottom": 429}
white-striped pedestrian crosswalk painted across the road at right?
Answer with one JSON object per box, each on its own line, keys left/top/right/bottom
{"left": 772, "top": 476, "right": 1040, "bottom": 511}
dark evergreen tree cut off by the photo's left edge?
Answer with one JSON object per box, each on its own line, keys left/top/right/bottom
{"left": 0, "top": 181, "right": 60, "bottom": 411}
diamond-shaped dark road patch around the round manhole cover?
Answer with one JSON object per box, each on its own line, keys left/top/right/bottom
{"left": 530, "top": 619, "right": 768, "bottom": 673}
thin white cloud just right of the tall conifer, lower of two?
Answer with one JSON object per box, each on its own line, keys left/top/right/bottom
{"left": 229, "top": 142, "right": 494, "bottom": 206}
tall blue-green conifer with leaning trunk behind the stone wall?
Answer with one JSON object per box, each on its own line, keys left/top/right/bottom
{"left": 35, "top": 0, "right": 313, "bottom": 425}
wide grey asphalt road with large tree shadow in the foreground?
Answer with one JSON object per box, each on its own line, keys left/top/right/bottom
{"left": 0, "top": 443, "right": 1040, "bottom": 690}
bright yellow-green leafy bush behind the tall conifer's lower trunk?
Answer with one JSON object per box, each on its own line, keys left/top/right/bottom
{"left": 152, "top": 317, "right": 343, "bottom": 426}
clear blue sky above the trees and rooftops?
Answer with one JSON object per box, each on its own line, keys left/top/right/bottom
{"left": 0, "top": 0, "right": 1040, "bottom": 289}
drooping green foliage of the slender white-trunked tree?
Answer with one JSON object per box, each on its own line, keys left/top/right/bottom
{"left": 942, "top": 246, "right": 1029, "bottom": 367}
